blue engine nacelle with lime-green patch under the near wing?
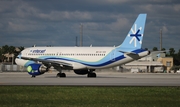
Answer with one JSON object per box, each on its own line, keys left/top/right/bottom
{"left": 27, "top": 64, "right": 47, "bottom": 76}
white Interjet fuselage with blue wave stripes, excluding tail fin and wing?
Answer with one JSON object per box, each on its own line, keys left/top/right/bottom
{"left": 16, "top": 47, "right": 148, "bottom": 69}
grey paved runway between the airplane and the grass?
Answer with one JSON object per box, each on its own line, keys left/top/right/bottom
{"left": 0, "top": 72, "right": 180, "bottom": 86}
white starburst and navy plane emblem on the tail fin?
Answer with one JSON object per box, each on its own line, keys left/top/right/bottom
{"left": 129, "top": 24, "right": 143, "bottom": 47}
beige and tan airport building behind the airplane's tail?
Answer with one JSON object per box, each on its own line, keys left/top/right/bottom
{"left": 120, "top": 51, "right": 173, "bottom": 73}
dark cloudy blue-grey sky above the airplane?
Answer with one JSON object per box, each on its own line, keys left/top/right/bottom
{"left": 0, "top": 0, "right": 180, "bottom": 51}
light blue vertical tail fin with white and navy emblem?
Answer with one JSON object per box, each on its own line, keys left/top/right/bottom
{"left": 119, "top": 14, "right": 146, "bottom": 49}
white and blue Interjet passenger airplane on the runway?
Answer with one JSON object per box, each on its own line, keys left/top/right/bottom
{"left": 15, "top": 14, "right": 150, "bottom": 77}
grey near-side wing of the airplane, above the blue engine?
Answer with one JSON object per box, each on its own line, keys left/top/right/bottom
{"left": 21, "top": 57, "right": 73, "bottom": 69}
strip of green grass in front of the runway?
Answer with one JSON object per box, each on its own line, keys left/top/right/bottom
{"left": 0, "top": 86, "right": 180, "bottom": 107}
